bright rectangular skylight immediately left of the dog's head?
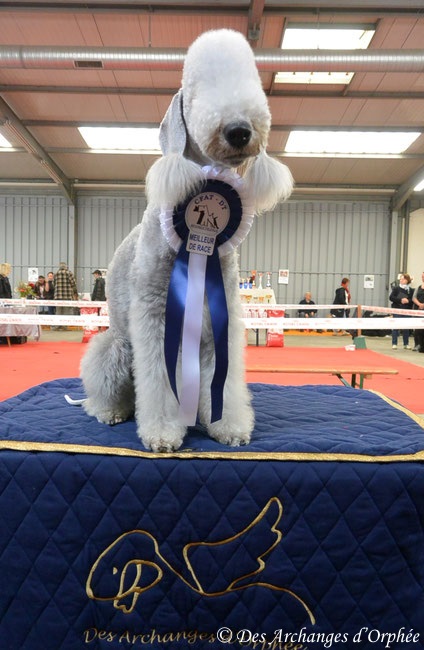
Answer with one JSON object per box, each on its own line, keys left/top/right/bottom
{"left": 78, "top": 126, "right": 160, "bottom": 152}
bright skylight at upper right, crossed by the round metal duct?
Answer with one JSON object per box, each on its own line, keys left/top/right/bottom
{"left": 275, "top": 23, "right": 375, "bottom": 85}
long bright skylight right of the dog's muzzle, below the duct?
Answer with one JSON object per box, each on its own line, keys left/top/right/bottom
{"left": 285, "top": 130, "right": 421, "bottom": 155}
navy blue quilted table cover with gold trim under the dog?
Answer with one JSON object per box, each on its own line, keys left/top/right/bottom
{"left": 0, "top": 379, "right": 424, "bottom": 650}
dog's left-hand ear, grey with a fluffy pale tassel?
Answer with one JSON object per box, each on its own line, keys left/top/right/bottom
{"left": 146, "top": 90, "right": 205, "bottom": 206}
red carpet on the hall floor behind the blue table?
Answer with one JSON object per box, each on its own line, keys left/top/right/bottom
{"left": 0, "top": 341, "right": 424, "bottom": 413}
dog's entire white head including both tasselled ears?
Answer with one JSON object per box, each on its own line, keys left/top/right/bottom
{"left": 147, "top": 29, "right": 293, "bottom": 211}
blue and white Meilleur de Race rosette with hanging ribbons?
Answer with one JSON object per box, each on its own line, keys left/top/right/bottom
{"left": 160, "top": 167, "right": 254, "bottom": 426}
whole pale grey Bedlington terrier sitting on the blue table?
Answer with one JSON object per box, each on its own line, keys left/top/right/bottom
{"left": 81, "top": 29, "right": 293, "bottom": 452}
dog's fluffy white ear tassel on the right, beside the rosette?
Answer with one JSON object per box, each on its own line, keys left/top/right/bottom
{"left": 243, "top": 150, "right": 294, "bottom": 213}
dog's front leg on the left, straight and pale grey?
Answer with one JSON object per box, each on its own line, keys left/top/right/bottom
{"left": 130, "top": 302, "right": 186, "bottom": 452}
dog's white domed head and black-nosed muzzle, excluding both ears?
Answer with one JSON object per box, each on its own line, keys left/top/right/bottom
{"left": 182, "top": 29, "right": 271, "bottom": 167}
